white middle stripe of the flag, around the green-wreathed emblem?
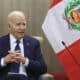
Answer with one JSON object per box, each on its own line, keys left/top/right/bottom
{"left": 42, "top": 0, "right": 80, "bottom": 53}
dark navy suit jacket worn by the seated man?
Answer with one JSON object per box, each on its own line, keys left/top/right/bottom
{"left": 0, "top": 35, "right": 47, "bottom": 80}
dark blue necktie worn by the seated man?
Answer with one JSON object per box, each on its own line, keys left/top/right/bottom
{"left": 10, "top": 40, "right": 21, "bottom": 73}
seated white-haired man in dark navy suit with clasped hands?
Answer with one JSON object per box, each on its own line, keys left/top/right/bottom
{"left": 0, "top": 11, "right": 47, "bottom": 80}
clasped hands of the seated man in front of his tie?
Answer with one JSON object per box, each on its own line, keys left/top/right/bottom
{"left": 4, "top": 51, "right": 26, "bottom": 64}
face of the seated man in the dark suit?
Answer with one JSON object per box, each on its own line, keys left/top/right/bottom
{"left": 9, "top": 16, "right": 26, "bottom": 39}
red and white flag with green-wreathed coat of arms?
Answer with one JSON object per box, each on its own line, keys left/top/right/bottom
{"left": 42, "top": 0, "right": 80, "bottom": 80}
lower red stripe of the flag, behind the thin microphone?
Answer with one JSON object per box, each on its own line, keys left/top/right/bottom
{"left": 57, "top": 40, "right": 80, "bottom": 80}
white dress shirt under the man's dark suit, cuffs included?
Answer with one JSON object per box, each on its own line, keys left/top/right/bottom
{"left": 1, "top": 34, "right": 29, "bottom": 76}
